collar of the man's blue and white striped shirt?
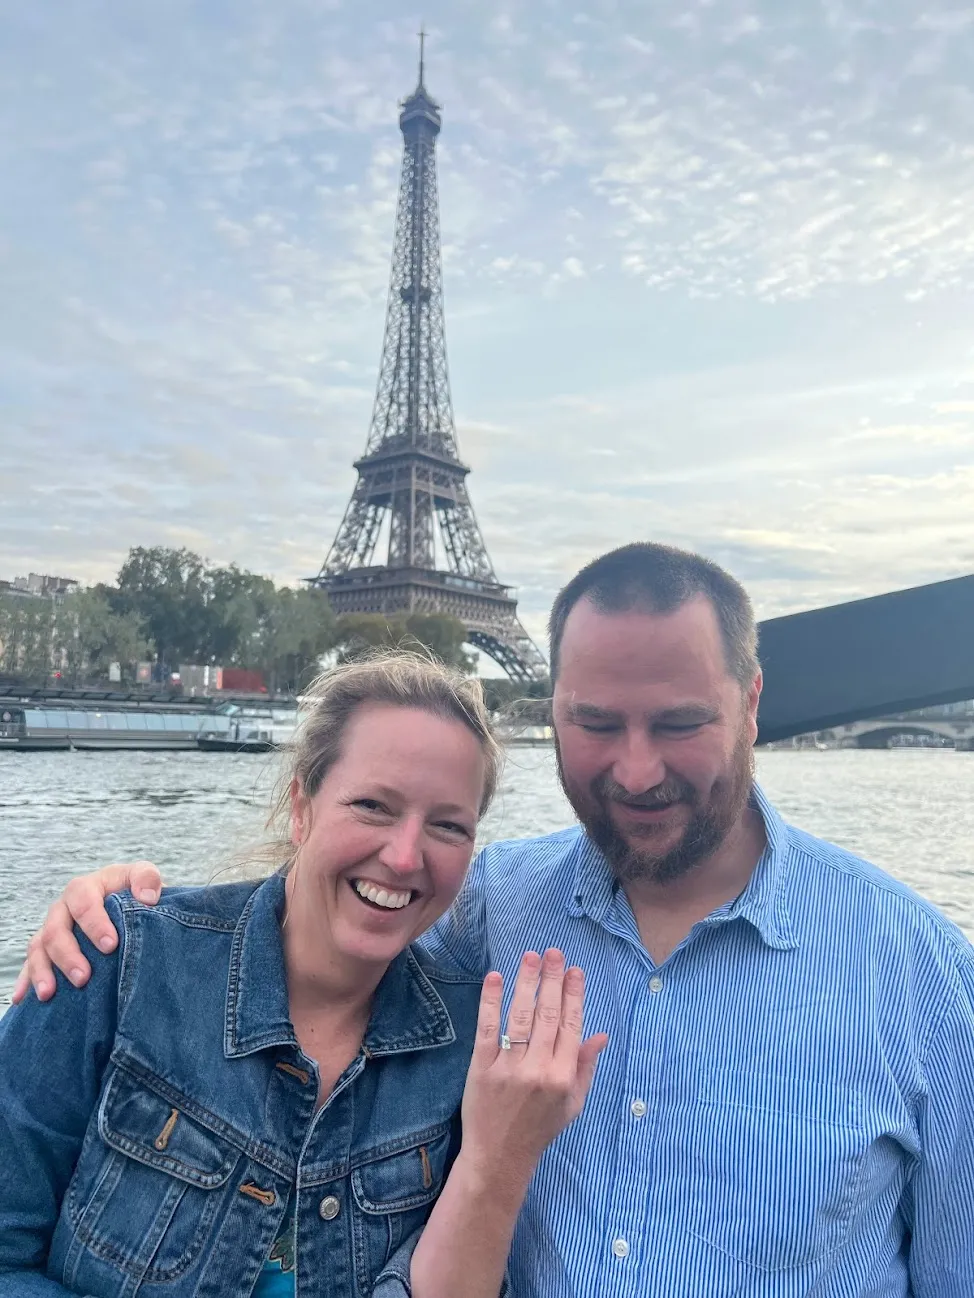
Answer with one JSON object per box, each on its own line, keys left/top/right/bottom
{"left": 568, "top": 784, "right": 799, "bottom": 950}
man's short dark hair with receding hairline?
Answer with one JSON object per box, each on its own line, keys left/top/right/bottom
{"left": 548, "top": 541, "right": 760, "bottom": 689}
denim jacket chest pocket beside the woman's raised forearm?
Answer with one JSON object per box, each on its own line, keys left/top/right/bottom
{"left": 352, "top": 1123, "right": 452, "bottom": 1293}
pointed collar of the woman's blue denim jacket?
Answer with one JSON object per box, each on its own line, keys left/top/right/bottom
{"left": 223, "top": 875, "right": 456, "bottom": 1059}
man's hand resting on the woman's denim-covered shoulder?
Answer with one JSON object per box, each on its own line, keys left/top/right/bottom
{"left": 12, "top": 861, "right": 162, "bottom": 1005}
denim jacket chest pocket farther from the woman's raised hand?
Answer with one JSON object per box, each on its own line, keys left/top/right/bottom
{"left": 66, "top": 1068, "right": 242, "bottom": 1288}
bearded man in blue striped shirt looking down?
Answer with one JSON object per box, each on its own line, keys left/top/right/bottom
{"left": 19, "top": 544, "right": 974, "bottom": 1298}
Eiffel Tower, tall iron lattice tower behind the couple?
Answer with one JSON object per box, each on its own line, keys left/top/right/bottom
{"left": 309, "top": 40, "right": 548, "bottom": 681}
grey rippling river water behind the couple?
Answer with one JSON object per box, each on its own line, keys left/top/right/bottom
{"left": 0, "top": 748, "right": 974, "bottom": 1012}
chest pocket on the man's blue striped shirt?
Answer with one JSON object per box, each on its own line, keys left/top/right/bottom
{"left": 686, "top": 1070, "right": 868, "bottom": 1271}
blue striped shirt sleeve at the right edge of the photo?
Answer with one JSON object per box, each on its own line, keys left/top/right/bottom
{"left": 905, "top": 959, "right": 974, "bottom": 1298}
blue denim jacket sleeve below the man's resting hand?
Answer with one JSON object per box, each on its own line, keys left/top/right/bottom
{"left": 0, "top": 915, "right": 121, "bottom": 1282}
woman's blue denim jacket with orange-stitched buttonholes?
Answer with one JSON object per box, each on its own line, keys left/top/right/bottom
{"left": 0, "top": 876, "right": 479, "bottom": 1298}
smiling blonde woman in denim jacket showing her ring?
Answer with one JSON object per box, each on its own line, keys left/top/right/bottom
{"left": 0, "top": 654, "right": 605, "bottom": 1298}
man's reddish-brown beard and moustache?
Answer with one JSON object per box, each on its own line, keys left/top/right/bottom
{"left": 555, "top": 731, "right": 755, "bottom": 884}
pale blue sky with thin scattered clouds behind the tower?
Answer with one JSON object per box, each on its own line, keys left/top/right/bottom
{"left": 0, "top": 0, "right": 974, "bottom": 659}
